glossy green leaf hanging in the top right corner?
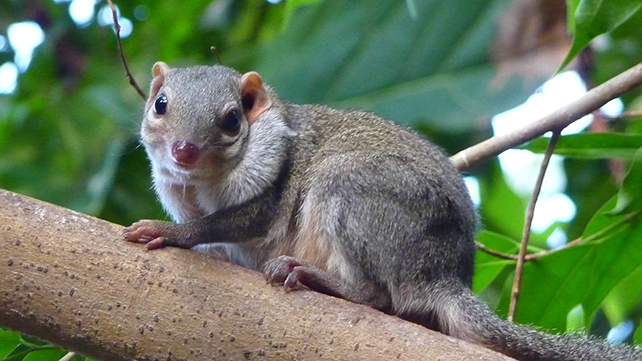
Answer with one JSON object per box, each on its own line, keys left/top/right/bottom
{"left": 560, "top": 0, "right": 642, "bottom": 69}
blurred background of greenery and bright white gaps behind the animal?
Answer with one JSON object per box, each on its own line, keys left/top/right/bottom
{"left": 0, "top": 0, "right": 642, "bottom": 356}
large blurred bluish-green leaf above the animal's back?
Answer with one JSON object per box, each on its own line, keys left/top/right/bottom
{"left": 254, "top": 0, "right": 537, "bottom": 131}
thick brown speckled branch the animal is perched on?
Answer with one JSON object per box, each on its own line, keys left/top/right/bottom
{"left": 0, "top": 190, "right": 509, "bottom": 361}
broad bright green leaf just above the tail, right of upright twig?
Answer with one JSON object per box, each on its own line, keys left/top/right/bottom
{"left": 502, "top": 200, "right": 642, "bottom": 331}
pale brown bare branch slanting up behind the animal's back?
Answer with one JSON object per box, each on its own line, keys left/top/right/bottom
{"left": 450, "top": 63, "right": 642, "bottom": 170}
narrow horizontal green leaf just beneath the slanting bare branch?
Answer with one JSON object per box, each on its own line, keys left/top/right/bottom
{"left": 519, "top": 133, "right": 642, "bottom": 159}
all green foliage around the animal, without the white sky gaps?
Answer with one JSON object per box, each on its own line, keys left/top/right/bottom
{"left": 0, "top": 0, "right": 642, "bottom": 360}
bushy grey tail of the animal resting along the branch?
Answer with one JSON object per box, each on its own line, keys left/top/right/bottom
{"left": 399, "top": 284, "right": 642, "bottom": 361}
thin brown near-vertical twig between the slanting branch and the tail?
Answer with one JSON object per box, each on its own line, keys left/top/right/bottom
{"left": 508, "top": 128, "right": 562, "bottom": 321}
